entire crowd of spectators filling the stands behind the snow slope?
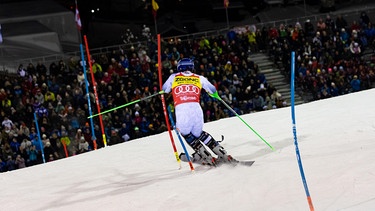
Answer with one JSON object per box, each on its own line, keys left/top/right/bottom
{"left": 0, "top": 10, "right": 375, "bottom": 172}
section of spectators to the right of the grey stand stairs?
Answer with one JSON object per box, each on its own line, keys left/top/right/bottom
{"left": 268, "top": 12, "right": 375, "bottom": 100}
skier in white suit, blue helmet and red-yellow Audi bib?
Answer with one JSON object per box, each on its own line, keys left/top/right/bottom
{"left": 162, "top": 58, "right": 236, "bottom": 166}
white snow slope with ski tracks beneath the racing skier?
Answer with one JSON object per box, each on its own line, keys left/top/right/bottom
{"left": 0, "top": 89, "right": 375, "bottom": 211}
